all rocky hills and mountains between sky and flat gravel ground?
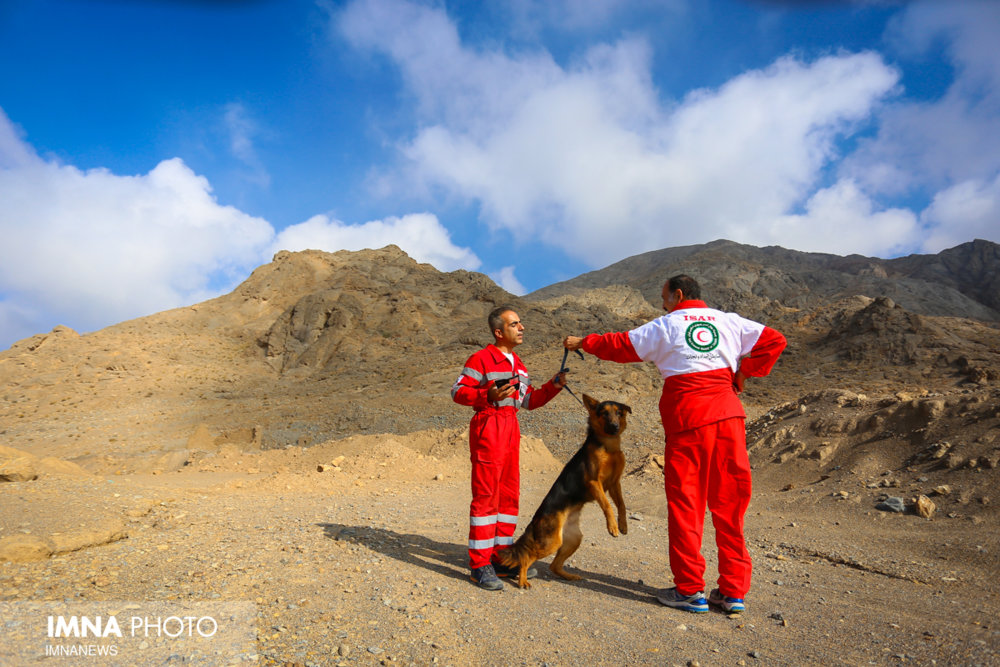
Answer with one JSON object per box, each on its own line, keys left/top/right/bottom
{"left": 0, "top": 241, "right": 1000, "bottom": 466}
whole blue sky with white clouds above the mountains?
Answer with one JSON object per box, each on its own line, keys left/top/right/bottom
{"left": 0, "top": 0, "right": 1000, "bottom": 347}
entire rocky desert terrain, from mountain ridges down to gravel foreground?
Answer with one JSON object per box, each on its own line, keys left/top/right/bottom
{"left": 0, "top": 241, "right": 1000, "bottom": 665}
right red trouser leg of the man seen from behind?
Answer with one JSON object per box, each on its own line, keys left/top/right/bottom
{"left": 708, "top": 417, "right": 753, "bottom": 598}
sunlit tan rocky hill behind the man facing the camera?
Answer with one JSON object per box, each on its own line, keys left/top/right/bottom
{"left": 0, "top": 246, "right": 668, "bottom": 458}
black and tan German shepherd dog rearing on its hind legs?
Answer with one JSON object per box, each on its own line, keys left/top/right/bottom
{"left": 498, "top": 394, "right": 632, "bottom": 588}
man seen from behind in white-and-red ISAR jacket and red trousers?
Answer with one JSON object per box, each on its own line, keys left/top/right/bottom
{"left": 563, "top": 275, "right": 786, "bottom": 612}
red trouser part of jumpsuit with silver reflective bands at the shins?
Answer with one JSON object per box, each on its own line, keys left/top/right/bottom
{"left": 469, "top": 408, "right": 521, "bottom": 569}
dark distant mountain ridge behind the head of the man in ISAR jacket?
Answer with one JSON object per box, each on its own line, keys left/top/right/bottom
{"left": 526, "top": 240, "right": 1000, "bottom": 322}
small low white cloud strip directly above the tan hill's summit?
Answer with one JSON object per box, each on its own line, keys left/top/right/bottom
{"left": 272, "top": 213, "right": 481, "bottom": 271}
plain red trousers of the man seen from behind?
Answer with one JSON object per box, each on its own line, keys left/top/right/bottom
{"left": 663, "top": 417, "right": 751, "bottom": 598}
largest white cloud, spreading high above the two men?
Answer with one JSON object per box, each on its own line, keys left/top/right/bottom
{"left": 339, "top": 0, "right": 905, "bottom": 266}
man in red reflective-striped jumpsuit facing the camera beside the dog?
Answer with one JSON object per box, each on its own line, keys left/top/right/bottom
{"left": 451, "top": 306, "right": 566, "bottom": 590}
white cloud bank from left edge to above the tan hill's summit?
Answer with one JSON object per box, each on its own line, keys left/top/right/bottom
{"left": 0, "top": 109, "right": 480, "bottom": 347}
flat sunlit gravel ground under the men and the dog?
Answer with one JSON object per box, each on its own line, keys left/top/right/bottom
{"left": 0, "top": 448, "right": 1000, "bottom": 665}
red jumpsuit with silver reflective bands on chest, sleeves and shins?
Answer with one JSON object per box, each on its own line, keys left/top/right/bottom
{"left": 451, "top": 345, "right": 559, "bottom": 569}
